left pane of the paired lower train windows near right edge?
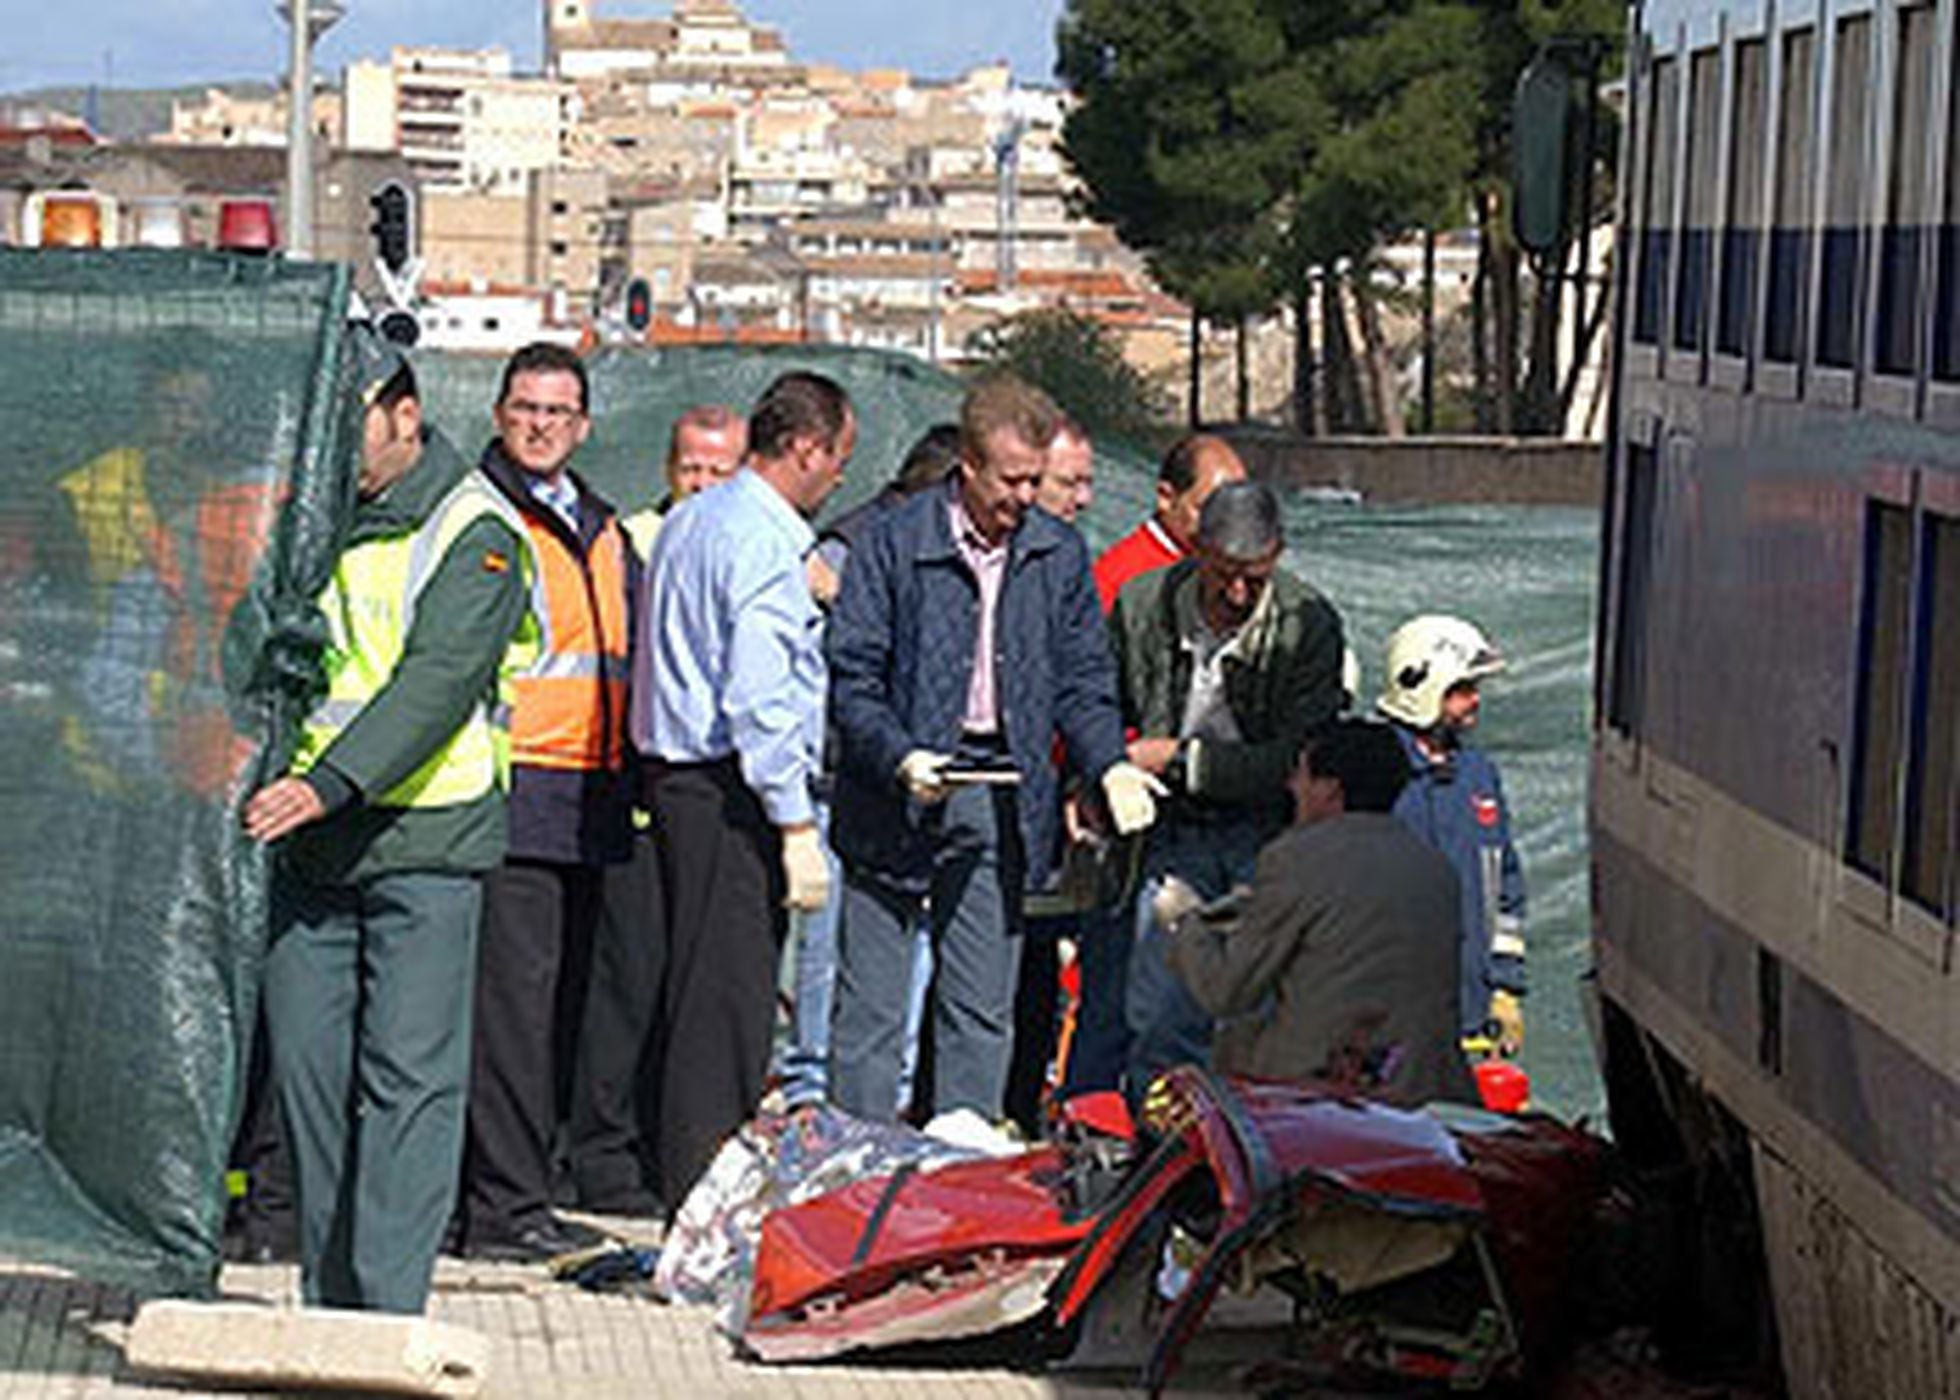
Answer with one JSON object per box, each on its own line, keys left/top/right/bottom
{"left": 1844, "top": 502, "right": 1913, "bottom": 882}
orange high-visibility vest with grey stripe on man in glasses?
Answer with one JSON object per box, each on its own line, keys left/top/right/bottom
{"left": 510, "top": 518, "right": 629, "bottom": 771}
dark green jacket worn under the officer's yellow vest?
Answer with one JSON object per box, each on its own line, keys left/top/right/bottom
{"left": 284, "top": 433, "right": 529, "bottom": 884}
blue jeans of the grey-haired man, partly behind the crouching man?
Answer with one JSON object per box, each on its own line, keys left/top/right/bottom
{"left": 1121, "top": 818, "right": 1266, "bottom": 1104}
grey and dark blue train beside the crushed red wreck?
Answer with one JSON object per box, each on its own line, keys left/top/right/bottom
{"left": 1588, "top": 0, "right": 1960, "bottom": 1400}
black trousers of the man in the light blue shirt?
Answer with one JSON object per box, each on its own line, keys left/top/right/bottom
{"left": 649, "top": 759, "right": 788, "bottom": 1210}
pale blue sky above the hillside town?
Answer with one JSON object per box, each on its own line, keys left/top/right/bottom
{"left": 0, "top": 0, "right": 1062, "bottom": 92}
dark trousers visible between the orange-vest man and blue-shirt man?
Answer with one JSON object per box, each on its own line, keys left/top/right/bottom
{"left": 570, "top": 831, "right": 666, "bottom": 1208}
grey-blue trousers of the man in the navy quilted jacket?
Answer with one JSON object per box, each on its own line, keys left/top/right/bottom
{"left": 831, "top": 786, "right": 1025, "bottom": 1122}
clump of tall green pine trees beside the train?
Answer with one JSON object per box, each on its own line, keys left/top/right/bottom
{"left": 1056, "top": 0, "right": 1621, "bottom": 429}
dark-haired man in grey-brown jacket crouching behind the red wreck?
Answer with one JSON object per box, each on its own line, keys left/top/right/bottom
{"left": 1156, "top": 720, "right": 1476, "bottom": 1106}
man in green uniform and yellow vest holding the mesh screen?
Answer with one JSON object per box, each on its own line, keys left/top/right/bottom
{"left": 245, "top": 339, "right": 537, "bottom": 1314}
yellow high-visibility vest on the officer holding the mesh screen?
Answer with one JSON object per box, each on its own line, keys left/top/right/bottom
{"left": 292, "top": 471, "right": 545, "bottom": 808}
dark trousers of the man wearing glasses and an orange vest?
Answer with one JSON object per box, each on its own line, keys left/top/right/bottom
{"left": 463, "top": 859, "right": 604, "bottom": 1239}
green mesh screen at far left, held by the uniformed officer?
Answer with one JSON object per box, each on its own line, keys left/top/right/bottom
{"left": 0, "top": 251, "right": 351, "bottom": 1292}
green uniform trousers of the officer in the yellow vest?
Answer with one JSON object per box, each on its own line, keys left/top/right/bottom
{"left": 265, "top": 875, "right": 480, "bottom": 1312}
